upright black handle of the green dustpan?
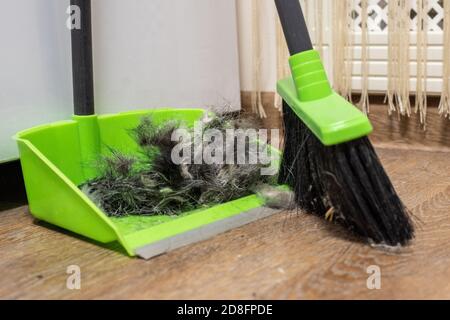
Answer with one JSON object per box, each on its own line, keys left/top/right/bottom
{"left": 70, "top": 0, "right": 95, "bottom": 116}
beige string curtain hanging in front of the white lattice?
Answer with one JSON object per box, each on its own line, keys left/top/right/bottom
{"left": 243, "top": 0, "right": 450, "bottom": 128}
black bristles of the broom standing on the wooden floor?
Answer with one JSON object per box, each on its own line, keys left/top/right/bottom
{"left": 279, "top": 102, "right": 414, "bottom": 246}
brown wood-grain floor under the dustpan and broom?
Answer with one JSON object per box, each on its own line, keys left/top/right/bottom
{"left": 0, "top": 149, "right": 450, "bottom": 299}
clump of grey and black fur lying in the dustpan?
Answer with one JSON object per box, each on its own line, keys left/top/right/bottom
{"left": 80, "top": 115, "right": 284, "bottom": 217}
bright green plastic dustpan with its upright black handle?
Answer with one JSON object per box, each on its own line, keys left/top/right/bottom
{"left": 15, "top": 0, "right": 276, "bottom": 258}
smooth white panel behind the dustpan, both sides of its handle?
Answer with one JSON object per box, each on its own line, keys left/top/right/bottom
{"left": 0, "top": 0, "right": 240, "bottom": 161}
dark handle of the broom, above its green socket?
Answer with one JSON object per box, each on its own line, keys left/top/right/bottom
{"left": 275, "top": 0, "right": 313, "bottom": 56}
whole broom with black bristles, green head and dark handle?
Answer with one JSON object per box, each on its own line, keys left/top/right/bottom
{"left": 275, "top": 0, "right": 414, "bottom": 246}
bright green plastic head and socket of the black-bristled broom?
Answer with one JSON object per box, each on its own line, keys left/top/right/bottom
{"left": 278, "top": 50, "right": 373, "bottom": 146}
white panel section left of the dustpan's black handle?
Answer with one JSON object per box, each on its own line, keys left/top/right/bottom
{"left": 0, "top": 0, "right": 72, "bottom": 161}
